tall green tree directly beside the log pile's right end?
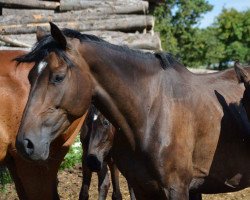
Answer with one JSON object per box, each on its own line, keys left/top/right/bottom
{"left": 153, "top": 0, "right": 212, "bottom": 66}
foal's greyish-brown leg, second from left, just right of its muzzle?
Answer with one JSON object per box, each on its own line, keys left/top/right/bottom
{"left": 97, "top": 163, "right": 110, "bottom": 200}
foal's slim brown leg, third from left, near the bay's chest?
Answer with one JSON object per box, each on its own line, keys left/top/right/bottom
{"left": 109, "top": 158, "right": 122, "bottom": 200}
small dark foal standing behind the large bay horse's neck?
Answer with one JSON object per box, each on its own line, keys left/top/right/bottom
{"left": 80, "top": 106, "right": 135, "bottom": 200}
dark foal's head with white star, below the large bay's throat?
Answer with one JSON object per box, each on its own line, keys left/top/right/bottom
{"left": 86, "top": 108, "right": 114, "bottom": 171}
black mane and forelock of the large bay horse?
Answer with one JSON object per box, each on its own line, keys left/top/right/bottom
{"left": 15, "top": 29, "right": 181, "bottom": 69}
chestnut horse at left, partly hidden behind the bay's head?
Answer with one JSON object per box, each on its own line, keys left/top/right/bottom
{"left": 0, "top": 51, "right": 87, "bottom": 200}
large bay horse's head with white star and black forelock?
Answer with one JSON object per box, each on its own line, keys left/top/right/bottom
{"left": 16, "top": 23, "right": 93, "bottom": 160}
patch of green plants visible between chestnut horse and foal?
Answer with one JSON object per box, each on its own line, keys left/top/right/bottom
{"left": 60, "top": 136, "right": 82, "bottom": 169}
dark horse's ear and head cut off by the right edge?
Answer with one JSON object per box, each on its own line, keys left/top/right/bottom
{"left": 234, "top": 61, "right": 250, "bottom": 120}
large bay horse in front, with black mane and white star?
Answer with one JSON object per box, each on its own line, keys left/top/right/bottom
{"left": 16, "top": 23, "right": 250, "bottom": 200}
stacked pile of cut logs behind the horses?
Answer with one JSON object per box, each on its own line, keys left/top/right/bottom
{"left": 0, "top": 0, "right": 161, "bottom": 50}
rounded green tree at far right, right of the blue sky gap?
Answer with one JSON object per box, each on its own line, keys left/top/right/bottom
{"left": 214, "top": 9, "right": 250, "bottom": 68}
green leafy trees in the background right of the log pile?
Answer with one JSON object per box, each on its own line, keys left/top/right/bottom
{"left": 153, "top": 0, "right": 250, "bottom": 69}
